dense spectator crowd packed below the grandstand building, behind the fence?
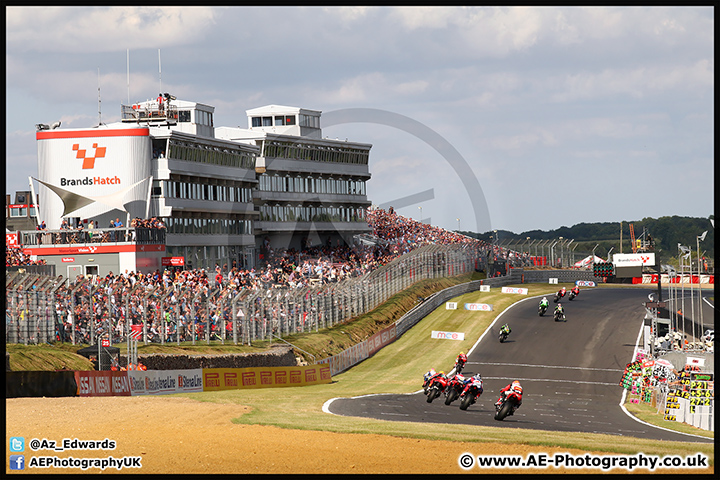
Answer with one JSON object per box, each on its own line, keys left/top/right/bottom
{"left": 6, "top": 208, "right": 499, "bottom": 343}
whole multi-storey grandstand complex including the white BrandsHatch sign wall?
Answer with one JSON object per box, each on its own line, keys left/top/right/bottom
{"left": 20, "top": 94, "right": 371, "bottom": 277}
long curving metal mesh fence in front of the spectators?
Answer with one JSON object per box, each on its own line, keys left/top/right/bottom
{"left": 5, "top": 244, "right": 486, "bottom": 345}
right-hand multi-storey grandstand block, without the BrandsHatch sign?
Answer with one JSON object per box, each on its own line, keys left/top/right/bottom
{"left": 215, "top": 105, "right": 371, "bottom": 255}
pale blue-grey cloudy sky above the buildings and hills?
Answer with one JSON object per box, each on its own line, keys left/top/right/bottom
{"left": 5, "top": 7, "right": 715, "bottom": 233}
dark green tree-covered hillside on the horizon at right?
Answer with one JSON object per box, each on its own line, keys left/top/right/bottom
{"left": 462, "top": 216, "right": 715, "bottom": 265}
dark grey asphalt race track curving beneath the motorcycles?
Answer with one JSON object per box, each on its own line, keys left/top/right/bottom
{"left": 325, "top": 288, "right": 713, "bottom": 443}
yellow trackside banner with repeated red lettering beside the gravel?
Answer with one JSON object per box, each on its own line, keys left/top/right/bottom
{"left": 202, "top": 364, "right": 332, "bottom": 392}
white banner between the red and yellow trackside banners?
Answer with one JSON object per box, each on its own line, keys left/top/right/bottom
{"left": 125, "top": 368, "right": 203, "bottom": 395}
